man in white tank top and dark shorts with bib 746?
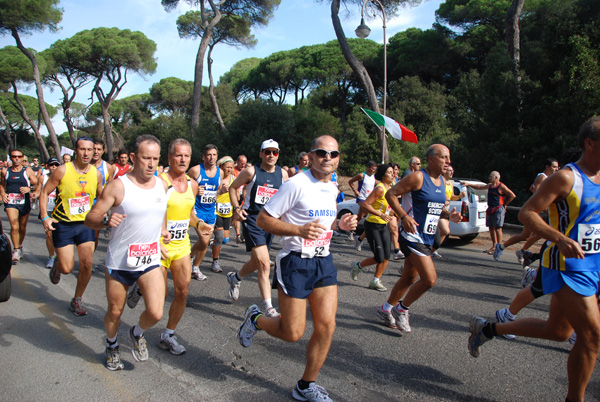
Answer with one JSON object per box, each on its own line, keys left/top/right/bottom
{"left": 85, "top": 135, "right": 171, "bottom": 371}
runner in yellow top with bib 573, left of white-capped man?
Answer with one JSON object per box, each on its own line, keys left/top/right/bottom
{"left": 211, "top": 156, "right": 234, "bottom": 272}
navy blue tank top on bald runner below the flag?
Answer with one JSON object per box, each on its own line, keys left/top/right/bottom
{"left": 400, "top": 169, "right": 446, "bottom": 246}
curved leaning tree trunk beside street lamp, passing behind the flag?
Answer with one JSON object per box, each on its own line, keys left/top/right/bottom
{"left": 331, "top": 0, "right": 389, "bottom": 162}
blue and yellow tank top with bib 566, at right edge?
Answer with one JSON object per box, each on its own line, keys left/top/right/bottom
{"left": 541, "top": 163, "right": 600, "bottom": 272}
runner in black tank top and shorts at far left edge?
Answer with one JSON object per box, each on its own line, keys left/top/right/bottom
{"left": 0, "top": 148, "right": 38, "bottom": 264}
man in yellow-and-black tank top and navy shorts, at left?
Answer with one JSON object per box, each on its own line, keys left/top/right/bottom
{"left": 40, "top": 137, "right": 102, "bottom": 316}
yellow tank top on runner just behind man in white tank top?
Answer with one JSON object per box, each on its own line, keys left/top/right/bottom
{"left": 160, "top": 173, "right": 196, "bottom": 250}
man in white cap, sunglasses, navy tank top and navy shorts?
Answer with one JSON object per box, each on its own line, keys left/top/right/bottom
{"left": 227, "top": 139, "right": 288, "bottom": 317}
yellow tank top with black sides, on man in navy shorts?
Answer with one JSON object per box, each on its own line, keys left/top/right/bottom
{"left": 52, "top": 162, "right": 98, "bottom": 222}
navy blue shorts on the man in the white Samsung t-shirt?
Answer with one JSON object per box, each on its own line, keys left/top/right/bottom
{"left": 274, "top": 251, "right": 337, "bottom": 299}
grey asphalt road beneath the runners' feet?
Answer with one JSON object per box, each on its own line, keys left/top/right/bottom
{"left": 0, "top": 217, "right": 600, "bottom": 401}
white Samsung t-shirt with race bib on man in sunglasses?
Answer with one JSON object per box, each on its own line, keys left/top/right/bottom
{"left": 264, "top": 170, "right": 338, "bottom": 257}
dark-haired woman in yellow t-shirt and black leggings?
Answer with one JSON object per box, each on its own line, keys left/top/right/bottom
{"left": 350, "top": 164, "right": 394, "bottom": 292}
